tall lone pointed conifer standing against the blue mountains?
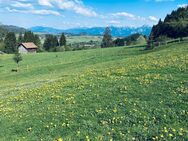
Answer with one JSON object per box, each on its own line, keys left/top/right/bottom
{"left": 101, "top": 27, "right": 113, "bottom": 48}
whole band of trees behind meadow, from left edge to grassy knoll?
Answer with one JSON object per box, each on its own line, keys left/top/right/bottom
{"left": 0, "top": 27, "right": 146, "bottom": 53}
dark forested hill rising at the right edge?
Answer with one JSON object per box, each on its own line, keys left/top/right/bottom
{"left": 150, "top": 7, "right": 188, "bottom": 40}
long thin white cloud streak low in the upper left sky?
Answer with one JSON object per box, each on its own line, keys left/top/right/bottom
{"left": 6, "top": 7, "right": 61, "bottom": 16}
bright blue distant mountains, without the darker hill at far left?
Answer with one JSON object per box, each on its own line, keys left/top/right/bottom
{"left": 29, "top": 26, "right": 151, "bottom": 36}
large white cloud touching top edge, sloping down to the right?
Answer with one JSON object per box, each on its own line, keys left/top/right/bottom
{"left": 38, "top": 0, "right": 97, "bottom": 17}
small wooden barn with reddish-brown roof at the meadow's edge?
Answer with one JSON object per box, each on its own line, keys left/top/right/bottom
{"left": 18, "top": 42, "right": 38, "bottom": 54}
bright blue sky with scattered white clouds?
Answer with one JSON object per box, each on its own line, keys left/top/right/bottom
{"left": 0, "top": 0, "right": 188, "bottom": 29}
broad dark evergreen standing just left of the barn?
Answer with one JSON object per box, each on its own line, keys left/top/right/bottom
{"left": 4, "top": 32, "right": 17, "bottom": 53}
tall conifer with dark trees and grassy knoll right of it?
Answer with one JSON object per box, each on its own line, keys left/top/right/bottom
{"left": 101, "top": 27, "right": 147, "bottom": 48}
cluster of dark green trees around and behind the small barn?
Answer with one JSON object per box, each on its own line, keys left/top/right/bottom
{"left": 0, "top": 29, "right": 70, "bottom": 54}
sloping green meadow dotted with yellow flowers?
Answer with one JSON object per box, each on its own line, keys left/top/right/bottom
{"left": 0, "top": 43, "right": 188, "bottom": 141}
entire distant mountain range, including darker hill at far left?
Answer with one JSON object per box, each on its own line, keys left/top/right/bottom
{"left": 0, "top": 23, "right": 152, "bottom": 37}
